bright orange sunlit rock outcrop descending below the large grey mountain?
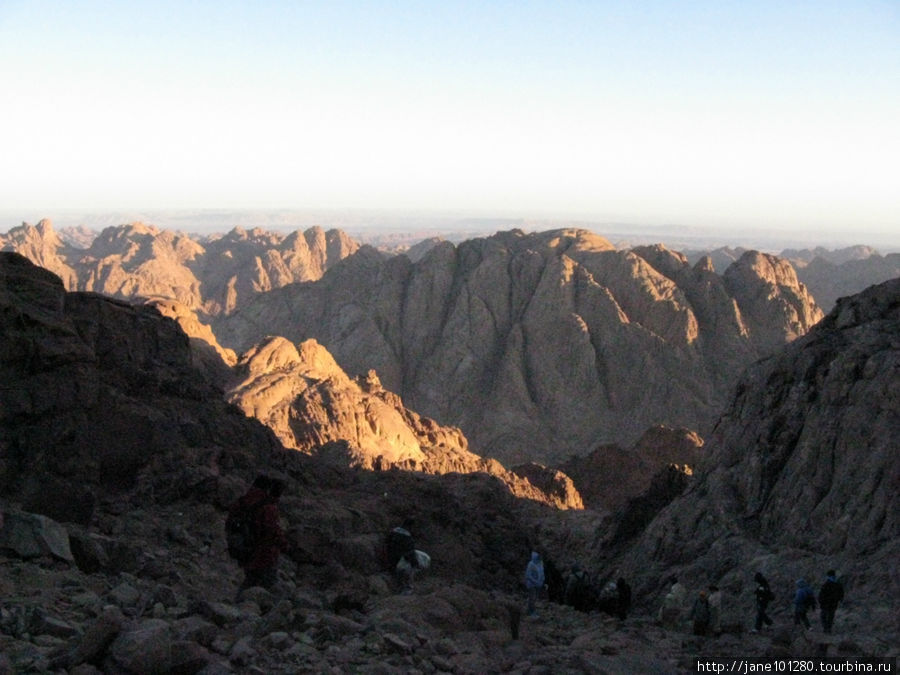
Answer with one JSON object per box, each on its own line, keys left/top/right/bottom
{"left": 227, "top": 337, "right": 583, "bottom": 509}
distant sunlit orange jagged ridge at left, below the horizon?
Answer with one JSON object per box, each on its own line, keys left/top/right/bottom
{"left": 0, "top": 220, "right": 358, "bottom": 317}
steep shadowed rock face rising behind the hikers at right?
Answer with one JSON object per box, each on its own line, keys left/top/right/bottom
{"left": 612, "top": 280, "right": 900, "bottom": 629}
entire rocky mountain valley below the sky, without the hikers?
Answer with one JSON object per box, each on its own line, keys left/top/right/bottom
{"left": 0, "top": 223, "right": 900, "bottom": 673}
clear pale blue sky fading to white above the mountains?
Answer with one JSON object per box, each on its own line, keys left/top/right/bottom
{"left": 0, "top": 0, "right": 900, "bottom": 240}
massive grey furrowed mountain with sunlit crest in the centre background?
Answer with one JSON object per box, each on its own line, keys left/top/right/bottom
{"left": 213, "top": 230, "right": 821, "bottom": 465}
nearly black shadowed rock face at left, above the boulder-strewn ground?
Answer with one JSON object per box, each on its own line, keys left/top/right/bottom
{"left": 0, "top": 253, "right": 284, "bottom": 522}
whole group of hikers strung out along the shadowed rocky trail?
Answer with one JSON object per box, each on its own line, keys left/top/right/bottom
{"left": 225, "top": 475, "right": 844, "bottom": 635}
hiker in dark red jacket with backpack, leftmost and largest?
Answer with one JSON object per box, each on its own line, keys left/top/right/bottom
{"left": 226, "top": 475, "right": 285, "bottom": 598}
